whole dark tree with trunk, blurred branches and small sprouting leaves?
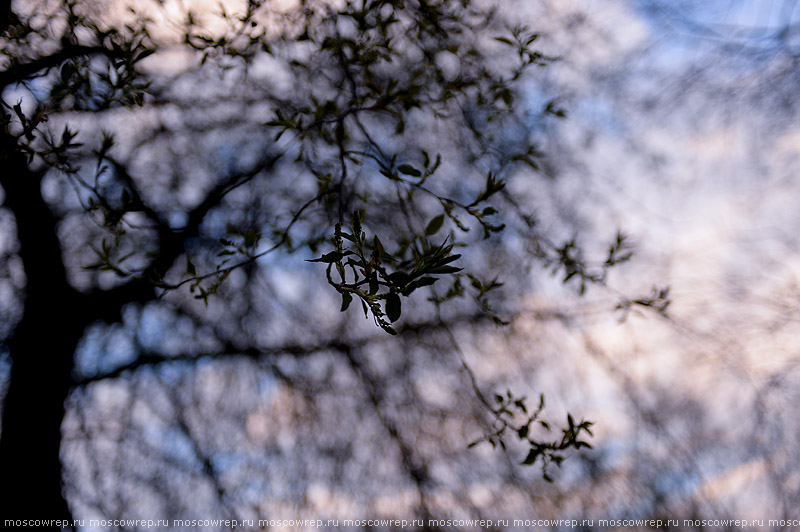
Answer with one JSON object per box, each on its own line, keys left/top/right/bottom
{"left": 0, "top": 0, "right": 608, "bottom": 518}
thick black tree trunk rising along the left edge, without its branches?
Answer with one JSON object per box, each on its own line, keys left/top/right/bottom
{"left": 0, "top": 125, "right": 86, "bottom": 519}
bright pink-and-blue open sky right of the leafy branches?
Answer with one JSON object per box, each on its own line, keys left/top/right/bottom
{"left": 488, "top": 1, "right": 800, "bottom": 530}
